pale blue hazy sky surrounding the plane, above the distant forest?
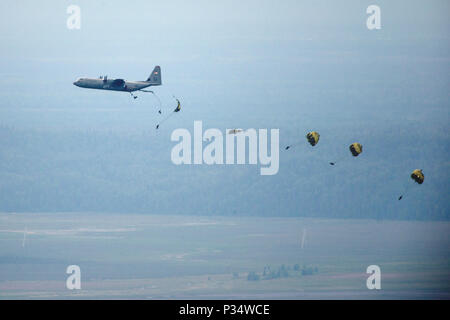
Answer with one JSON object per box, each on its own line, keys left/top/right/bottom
{"left": 0, "top": 1, "right": 450, "bottom": 125}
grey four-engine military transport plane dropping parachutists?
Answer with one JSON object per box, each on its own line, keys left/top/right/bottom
{"left": 73, "top": 66, "right": 161, "bottom": 99}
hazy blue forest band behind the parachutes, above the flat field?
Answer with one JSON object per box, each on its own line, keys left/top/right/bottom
{"left": 0, "top": 127, "right": 450, "bottom": 220}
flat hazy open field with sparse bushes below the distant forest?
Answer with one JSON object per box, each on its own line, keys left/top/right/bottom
{"left": 0, "top": 213, "right": 450, "bottom": 299}
